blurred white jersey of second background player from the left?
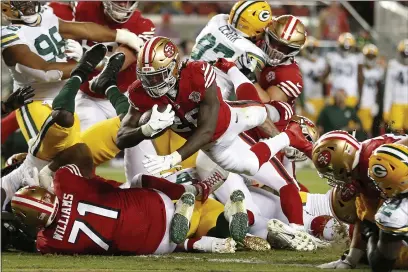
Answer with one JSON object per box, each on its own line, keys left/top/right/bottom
{"left": 326, "top": 52, "right": 362, "bottom": 97}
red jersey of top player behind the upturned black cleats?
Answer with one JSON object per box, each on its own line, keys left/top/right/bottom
{"left": 74, "top": 1, "right": 155, "bottom": 98}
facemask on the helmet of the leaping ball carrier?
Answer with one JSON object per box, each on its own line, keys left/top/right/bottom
{"left": 137, "top": 60, "right": 177, "bottom": 98}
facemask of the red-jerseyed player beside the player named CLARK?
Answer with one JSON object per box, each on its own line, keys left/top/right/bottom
{"left": 262, "top": 31, "right": 299, "bottom": 66}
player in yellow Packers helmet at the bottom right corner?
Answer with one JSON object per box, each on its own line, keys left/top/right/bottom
{"left": 367, "top": 144, "right": 408, "bottom": 272}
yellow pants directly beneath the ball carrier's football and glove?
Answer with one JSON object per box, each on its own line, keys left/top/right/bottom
{"left": 153, "top": 129, "right": 197, "bottom": 168}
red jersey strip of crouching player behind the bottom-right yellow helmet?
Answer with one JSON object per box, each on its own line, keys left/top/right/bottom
{"left": 355, "top": 134, "right": 404, "bottom": 197}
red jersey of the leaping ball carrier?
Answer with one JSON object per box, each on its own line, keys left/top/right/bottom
{"left": 128, "top": 61, "right": 231, "bottom": 141}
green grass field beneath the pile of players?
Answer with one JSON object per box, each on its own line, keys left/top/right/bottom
{"left": 1, "top": 168, "right": 369, "bottom": 272}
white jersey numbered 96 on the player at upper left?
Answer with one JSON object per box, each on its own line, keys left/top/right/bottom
{"left": 1, "top": 8, "right": 67, "bottom": 100}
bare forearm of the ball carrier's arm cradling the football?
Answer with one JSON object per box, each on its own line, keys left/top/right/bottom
{"left": 116, "top": 106, "right": 147, "bottom": 150}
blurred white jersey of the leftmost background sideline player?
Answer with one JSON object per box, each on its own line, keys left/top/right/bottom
{"left": 296, "top": 57, "right": 327, "bottom": 99}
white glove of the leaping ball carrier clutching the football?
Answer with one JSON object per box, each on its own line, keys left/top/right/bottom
{"left": 140, "top": 105, "right": 174, "bottom": 137}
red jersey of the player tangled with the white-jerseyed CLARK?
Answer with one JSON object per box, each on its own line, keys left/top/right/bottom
{"left": 259, "top": 61, "right": 303, "bottom": 131}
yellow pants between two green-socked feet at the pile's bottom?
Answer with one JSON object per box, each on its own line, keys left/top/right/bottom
{"left": 187, "top": 198, "right": 224, "bottom": 238}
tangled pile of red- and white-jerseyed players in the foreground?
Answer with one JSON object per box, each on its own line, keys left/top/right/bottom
{"left": 1, "top": 1, "right": 408, "bottom": 271}
